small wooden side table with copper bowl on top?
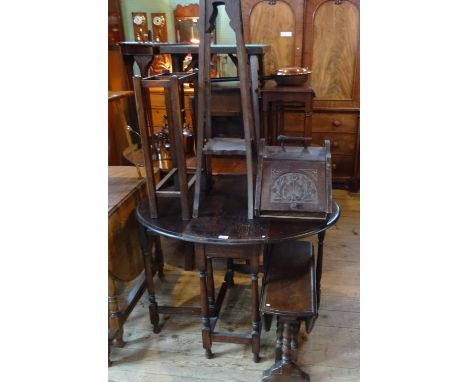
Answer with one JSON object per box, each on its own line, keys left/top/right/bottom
{"left": 261, "top": 81, "right": 315, "bottom": 145}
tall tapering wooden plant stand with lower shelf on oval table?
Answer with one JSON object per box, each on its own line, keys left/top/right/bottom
{"left": 193, "top": 0, "right": 255, "bottom": 219}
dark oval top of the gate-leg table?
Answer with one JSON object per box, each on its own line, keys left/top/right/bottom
{"left": 137, "top": 175, "right": 340, "bottom": 245}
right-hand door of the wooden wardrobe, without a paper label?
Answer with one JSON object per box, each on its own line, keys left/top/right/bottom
{"left": 304, "top": 0, "right": 359, "bottom": 106}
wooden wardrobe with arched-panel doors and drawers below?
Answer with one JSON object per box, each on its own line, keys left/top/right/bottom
{"left": 241, "top": 0, "right": 360, "bottom": 189}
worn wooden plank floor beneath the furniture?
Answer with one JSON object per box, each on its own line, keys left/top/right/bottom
{"left": 109, "top": 190, "right": 360, "bottom": 382}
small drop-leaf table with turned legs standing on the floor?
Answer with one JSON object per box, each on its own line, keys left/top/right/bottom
{"left": 260, "top": 241, "right": 318, "bottom": 382}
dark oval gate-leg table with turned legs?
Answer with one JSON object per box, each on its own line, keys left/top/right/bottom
{"left": 137, "top": 175, "right": 340, "bottom": 362}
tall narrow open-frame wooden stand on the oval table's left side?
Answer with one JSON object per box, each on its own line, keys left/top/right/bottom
{"left": 133, "top": 72, "right": 197, "bottom": 220}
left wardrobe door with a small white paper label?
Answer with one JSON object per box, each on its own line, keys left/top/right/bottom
{"left": 241, "top": 0, "right": 304, "bottom": 74}
